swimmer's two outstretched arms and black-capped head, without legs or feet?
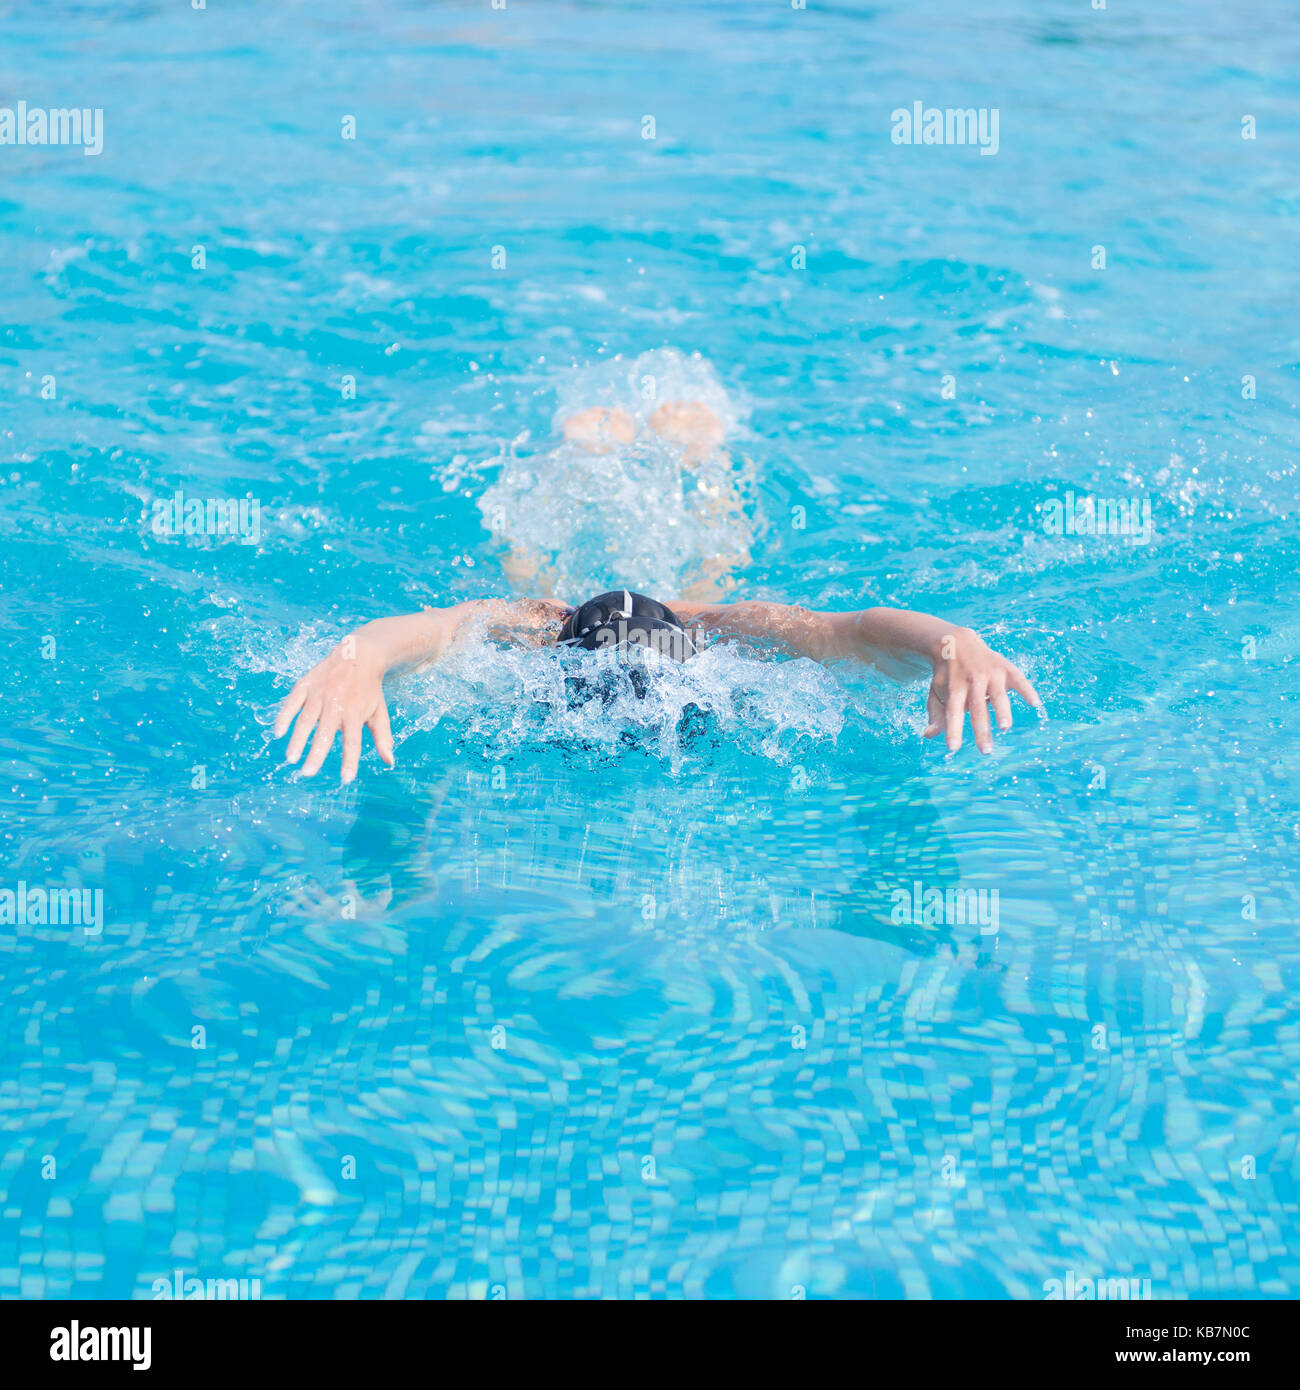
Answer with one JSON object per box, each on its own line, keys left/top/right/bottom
{"left": 274, "top": 589, "right": 1041, "bottom": 783}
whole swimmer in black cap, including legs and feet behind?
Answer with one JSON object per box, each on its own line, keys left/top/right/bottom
{"left": 275, "top": 399, "right": 1041, "bottom": 783}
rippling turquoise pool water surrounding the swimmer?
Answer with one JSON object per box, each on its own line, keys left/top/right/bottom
{"left": 0, "top": 0, "right": 1300, "bottom": 1298}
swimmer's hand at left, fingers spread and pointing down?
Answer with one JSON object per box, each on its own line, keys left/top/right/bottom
{"left": 275, "top": 632, "right": 393, "bottom": 783}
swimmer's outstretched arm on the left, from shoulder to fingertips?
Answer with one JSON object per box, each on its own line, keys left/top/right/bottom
{"left": 274, "top": 599, "right": 562, "bottom": 783}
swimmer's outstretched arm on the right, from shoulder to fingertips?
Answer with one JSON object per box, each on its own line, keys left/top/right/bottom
{"left": 670, "top": 602, "right": 1043, "bottom": 753}
